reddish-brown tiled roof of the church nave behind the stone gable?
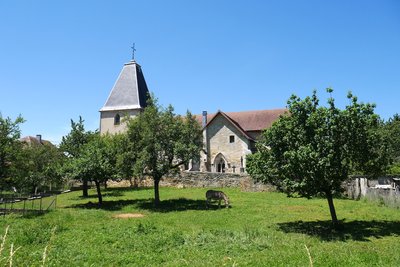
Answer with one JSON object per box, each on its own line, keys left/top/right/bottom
{"left": 196, "top": 109, "right": 287, "bottom": 132}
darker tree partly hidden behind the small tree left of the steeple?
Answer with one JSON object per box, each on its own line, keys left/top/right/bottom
{"left": 60, "top": 116, "right": 94, "bottom": 197}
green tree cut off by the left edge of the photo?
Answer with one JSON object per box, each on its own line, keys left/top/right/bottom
{"left": 0, "top": 114, "right": 24, "bottom": 187}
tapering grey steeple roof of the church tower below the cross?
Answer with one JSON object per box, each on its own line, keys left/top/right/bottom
{"left": 100, "top": 60, "right": 149, "bottom": 111}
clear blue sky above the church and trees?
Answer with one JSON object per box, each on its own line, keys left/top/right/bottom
{"left": 0, "top": 0, "right": 400, "bottom": 146}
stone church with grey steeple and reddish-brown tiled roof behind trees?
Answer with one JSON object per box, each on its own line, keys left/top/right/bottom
{"left": 100, "top": 60, "right": 286, "bottom": 173}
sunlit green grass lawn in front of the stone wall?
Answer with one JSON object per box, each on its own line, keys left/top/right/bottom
{"left": 0, "top": 188, "right": 400, "bottom": 266}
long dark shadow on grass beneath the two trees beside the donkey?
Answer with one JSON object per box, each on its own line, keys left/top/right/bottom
{"left": 67, "top": 198, "right": 230, "bottom": 212}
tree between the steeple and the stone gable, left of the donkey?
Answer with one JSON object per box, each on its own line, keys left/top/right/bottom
{"left": 127, "top": 100, "right": 202, "bottom": 206}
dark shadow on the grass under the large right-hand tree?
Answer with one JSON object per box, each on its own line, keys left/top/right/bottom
{"left": 278, "top": 220, "right": 400, "bottom": 241}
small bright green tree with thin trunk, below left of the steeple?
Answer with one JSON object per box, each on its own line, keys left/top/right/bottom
{"left": 70, "top": 133, "right": 115, "bottom": 205}
